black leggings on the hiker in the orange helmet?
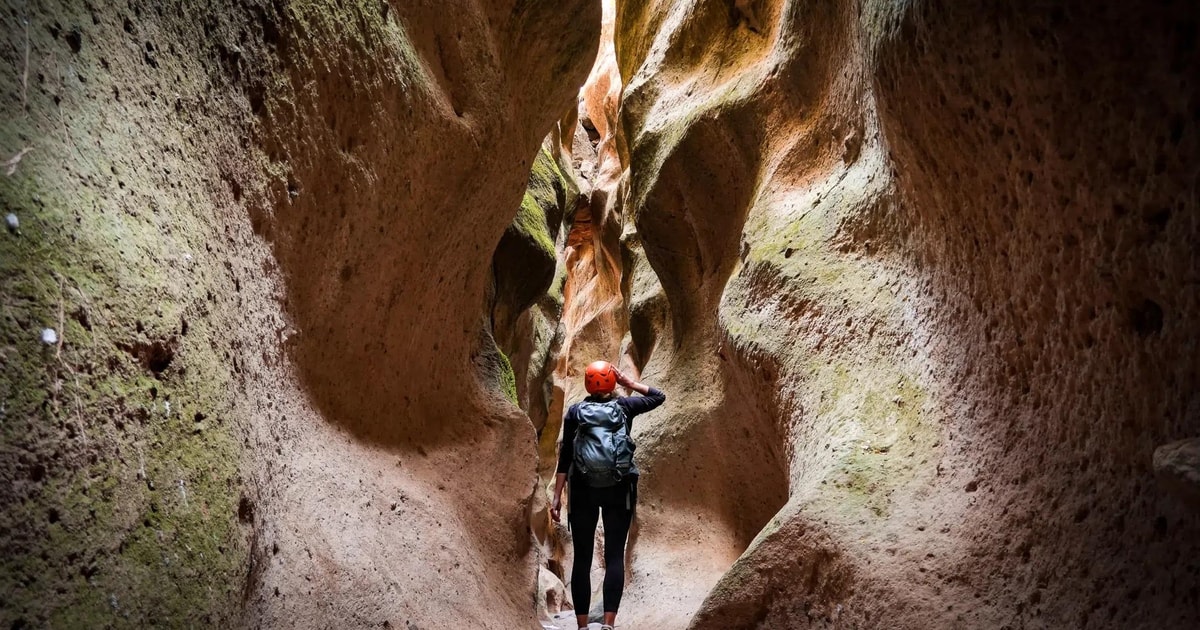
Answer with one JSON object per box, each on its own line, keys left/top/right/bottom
{"left": 568, "top": 476, "right": 637, "bottom": 614}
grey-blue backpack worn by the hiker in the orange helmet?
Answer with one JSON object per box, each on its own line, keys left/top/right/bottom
{"left": 575, "top": 401, "right": 634, "bottom": 488}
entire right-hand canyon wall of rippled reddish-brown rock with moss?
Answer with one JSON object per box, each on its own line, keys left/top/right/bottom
{"left": 604, "top": 0, "right": 1200, "bottom": 629}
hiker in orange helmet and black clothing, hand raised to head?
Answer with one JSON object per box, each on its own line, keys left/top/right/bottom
{"left": 550, "top": 361, "right": 667, "bottom": 630}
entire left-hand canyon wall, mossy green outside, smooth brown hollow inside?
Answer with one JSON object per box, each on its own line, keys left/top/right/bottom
{"left": 0, "top": 0, "right": 600, "bottom": 628}
